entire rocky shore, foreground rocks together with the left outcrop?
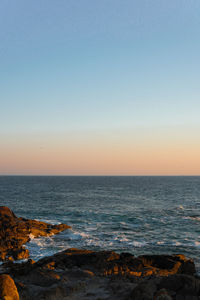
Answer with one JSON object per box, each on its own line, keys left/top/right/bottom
{"left": 0, "top": 207, "right": 200, "bottom": 300}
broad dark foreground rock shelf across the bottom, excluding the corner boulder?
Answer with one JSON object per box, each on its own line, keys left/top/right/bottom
{"left": 1, "top": 249, "right": 200, "bottom": 300}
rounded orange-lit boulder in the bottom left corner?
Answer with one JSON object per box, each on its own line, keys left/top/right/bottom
{"left": 0, "top": 274, "right": 19, "bottom": 300}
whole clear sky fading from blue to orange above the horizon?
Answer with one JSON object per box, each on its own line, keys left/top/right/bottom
{"left": 0, "top": 0, "right": 200, "bottom": 175}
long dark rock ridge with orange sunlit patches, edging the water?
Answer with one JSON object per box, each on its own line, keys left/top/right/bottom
{"left": 30, "top": 248, "right": 195, "bottom": 277}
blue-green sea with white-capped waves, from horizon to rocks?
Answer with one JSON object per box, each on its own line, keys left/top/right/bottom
{"left": 0, "top": 176, "right": 200, "bottom": 269}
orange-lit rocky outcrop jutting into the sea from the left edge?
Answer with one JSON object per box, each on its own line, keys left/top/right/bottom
{"left": 0, "top": 206, "right": 70, "bottom": 260}
